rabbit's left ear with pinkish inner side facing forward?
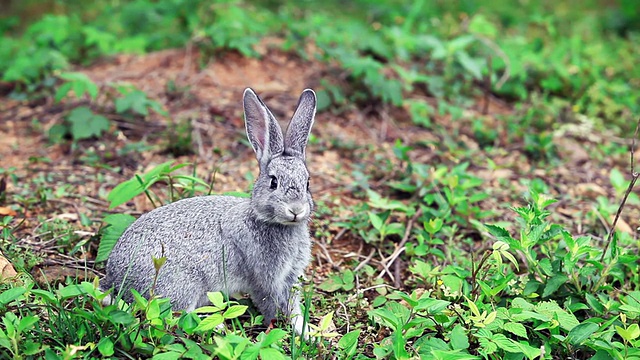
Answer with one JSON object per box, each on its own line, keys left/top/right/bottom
{"left": 243, "top": 88, "right": 284, "bottom": 165}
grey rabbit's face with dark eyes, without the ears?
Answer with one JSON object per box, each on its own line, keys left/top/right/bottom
{"left": 252, "top": 155, "right": 313, "bottom": 225}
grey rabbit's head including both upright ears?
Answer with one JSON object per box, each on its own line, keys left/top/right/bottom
{"left": 244, "top": 89, "right": 316, "bottom": 225}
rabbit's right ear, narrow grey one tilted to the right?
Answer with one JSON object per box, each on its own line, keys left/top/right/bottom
{"left": 284, "top": 89, "right": 316, "bottom": 159}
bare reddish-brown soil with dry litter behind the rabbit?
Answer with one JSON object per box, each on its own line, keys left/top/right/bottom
{"left": 0, "top": 44, "right": 640, "bottom": 318}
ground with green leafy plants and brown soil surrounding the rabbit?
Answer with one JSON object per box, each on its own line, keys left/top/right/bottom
{"left": 0, "top": 0, "right": 640, "bottom": 359}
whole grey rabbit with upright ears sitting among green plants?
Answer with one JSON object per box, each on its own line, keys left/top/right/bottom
{"left": 99, "top": 88, "right": 316, "bottom": 338}
